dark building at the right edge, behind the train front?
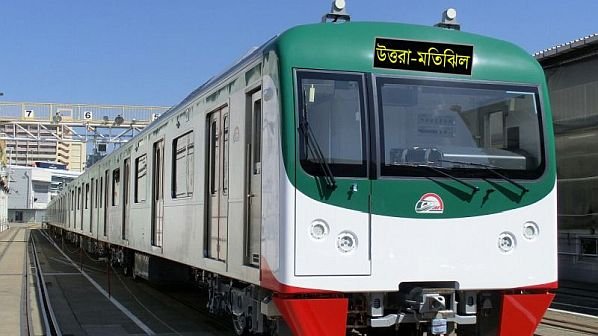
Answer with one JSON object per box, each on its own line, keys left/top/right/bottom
{"left": 534, "top": 34, "right": 598, "bottom": 283}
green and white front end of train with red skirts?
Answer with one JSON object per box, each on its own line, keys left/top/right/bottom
{"left": 261, "top": 11, "right": 557, "bottom": 335}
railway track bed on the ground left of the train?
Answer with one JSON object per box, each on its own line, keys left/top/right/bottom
{"left": 31, "top": 230, "right": 233, "bottom": 336}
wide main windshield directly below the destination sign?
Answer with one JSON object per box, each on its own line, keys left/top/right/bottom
{"left": 376, "top": 77, "right": 544, "bottom": 178}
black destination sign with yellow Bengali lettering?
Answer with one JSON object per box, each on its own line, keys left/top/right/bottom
{"left": 374, "top": 38, "right": 473, "bottom": 75}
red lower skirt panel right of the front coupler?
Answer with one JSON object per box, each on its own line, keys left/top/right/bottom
{"left": 499, "top": 293, "right": 554, "bottom": 336}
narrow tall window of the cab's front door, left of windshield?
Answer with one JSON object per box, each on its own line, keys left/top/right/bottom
{"left": 297, "top": 71, "right": 367, "bottom": 177}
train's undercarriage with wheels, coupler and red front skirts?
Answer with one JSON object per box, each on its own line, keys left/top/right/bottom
{"left": 44, "top": 226, "right": 554, "bottom": 336}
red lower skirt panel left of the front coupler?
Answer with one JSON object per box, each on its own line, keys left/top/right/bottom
{"left": 274, "top": 296, "right": 349, "bottom": 336}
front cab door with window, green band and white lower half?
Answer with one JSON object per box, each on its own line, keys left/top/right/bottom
{"left": 295, "top": 71, "right": 372, "bottom": 276}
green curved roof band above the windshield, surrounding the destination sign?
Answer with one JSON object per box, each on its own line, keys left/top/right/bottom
{"left": 273, "top": 22, "right": 544, "bottom": 84}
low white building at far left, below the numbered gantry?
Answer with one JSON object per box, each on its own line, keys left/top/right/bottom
{"left": 7, "top": 165, "right": 81, "bottom": 223}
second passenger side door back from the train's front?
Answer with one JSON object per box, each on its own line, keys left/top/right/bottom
{"left": 152, "top": 139, "right": 164, "bottom": 247}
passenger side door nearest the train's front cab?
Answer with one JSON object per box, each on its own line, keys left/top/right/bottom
{"left": 206, "top": 107, "right": 229, "bottom": 261}
